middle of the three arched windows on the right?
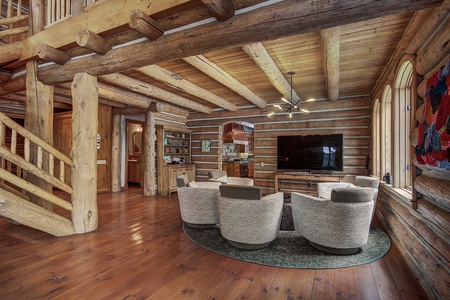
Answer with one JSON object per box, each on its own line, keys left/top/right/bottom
{"left": 380, "top": 84, "right": 392, "bottom": 178}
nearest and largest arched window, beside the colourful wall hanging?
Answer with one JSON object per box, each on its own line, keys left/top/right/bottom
{"left": 392, "top": 61, "right": 415, "bottom": 190}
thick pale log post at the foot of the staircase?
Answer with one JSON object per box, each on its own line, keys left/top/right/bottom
{"left": 71, "top": 73, "right": 98, "bottom": 233}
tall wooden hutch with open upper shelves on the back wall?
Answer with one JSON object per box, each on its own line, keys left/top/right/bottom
{"left": 156, "top": 126, "right": 196, "bottom": 195}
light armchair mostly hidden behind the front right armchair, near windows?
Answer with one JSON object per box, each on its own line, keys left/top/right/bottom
{"left": 317, "top": 175, "right": 380, "bottom": 220}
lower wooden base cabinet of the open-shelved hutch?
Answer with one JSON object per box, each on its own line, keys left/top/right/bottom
{"left": 158, "top": 164, "right": 195, "bottom": 195}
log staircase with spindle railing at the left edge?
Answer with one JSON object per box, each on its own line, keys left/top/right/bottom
{"left": 0, "top": 113, "right": 75, "bottom": 236}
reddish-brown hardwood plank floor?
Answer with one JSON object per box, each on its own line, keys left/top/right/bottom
{"left": 0, "top": 188, "right": 426, "bottom": 300}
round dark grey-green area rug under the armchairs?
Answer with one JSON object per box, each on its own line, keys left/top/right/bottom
{"left": 183, "top": 224, "right": 391, "bottom": 269}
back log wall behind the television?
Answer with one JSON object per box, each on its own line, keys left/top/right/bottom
{"left": 187, "top": 97, "right": 371, "bottom": 193}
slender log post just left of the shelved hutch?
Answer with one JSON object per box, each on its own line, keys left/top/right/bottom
{"left": 144, "top": 112, "right": 156, "bottom": 196}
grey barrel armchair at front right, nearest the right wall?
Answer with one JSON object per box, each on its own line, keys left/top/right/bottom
{"left": 291, "top": 188, "right": 374, "bottom": 254}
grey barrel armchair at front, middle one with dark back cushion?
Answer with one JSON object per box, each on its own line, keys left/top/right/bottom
{"left": 218, "top": 184, "right": 283, "bottom": 249}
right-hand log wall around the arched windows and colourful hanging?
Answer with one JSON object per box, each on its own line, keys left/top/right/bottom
{"left": 374, "top": 4, "right": 450, "bottom": 299}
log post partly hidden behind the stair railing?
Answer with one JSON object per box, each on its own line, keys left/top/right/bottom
{"left": 25, "top": 60, "right": 54, "bottom": 211}
